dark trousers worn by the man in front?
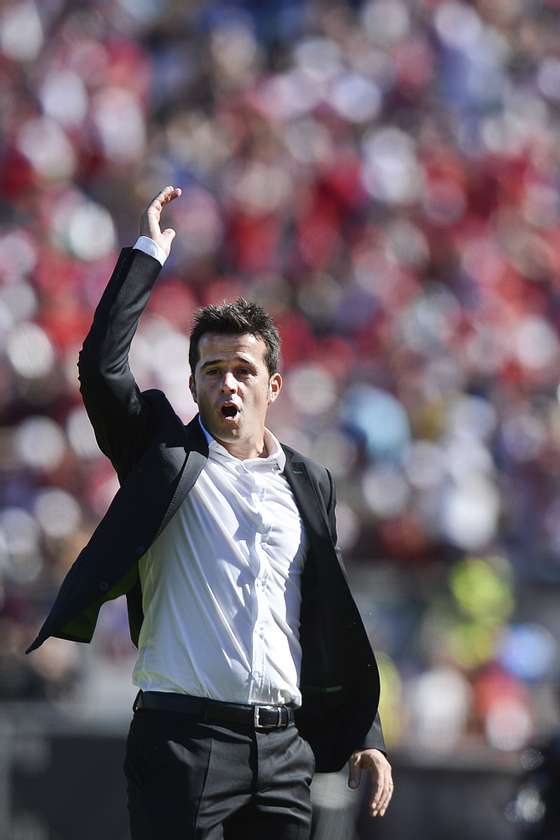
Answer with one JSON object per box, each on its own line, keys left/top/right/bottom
{"left": 124, "top": 709, "right": 314, "bottom": 840}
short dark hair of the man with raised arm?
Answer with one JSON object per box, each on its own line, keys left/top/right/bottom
{"left": 189, "top": 298, "right": 280, "bottom": 376}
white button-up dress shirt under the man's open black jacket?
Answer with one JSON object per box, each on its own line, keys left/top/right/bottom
{"left": 133, "top": 424, "right": 306, "bottom": 705}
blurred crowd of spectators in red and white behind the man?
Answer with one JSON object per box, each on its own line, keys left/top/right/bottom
{"left": 0, "top": 0, "right": 560, "bottom": 754}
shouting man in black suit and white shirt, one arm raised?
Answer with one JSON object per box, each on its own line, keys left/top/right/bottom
{"left": 29, "top": 187, "right": 392, "bottom": 840}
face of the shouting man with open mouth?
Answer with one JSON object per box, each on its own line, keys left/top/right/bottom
{"left": 189, "top": 333, "right": 282, "bottom": 457}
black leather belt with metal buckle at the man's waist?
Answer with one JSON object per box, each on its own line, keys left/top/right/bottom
{"left": 133, "top": 691, "right": 294, "bottom": 731}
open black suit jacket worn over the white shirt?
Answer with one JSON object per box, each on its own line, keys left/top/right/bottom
{"left": 28, "top": 248, "right": 384, "bottom": 772}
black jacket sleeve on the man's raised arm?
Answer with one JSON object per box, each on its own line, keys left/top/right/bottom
{"left": 78, "top": 248, "right": 161, "bottom": 477}
